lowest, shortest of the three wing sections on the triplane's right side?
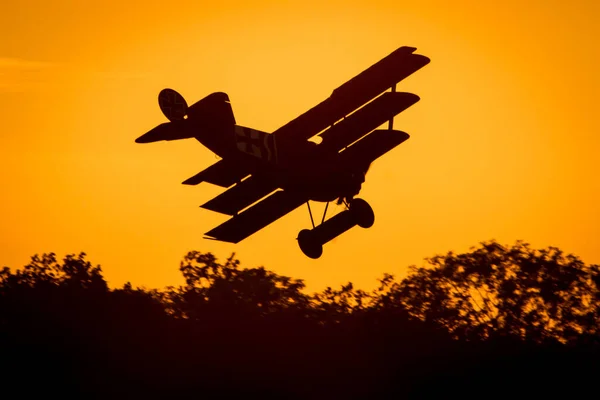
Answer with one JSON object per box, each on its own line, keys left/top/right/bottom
{"left": 340, "top": 129, "right": 410, "bottom": 165}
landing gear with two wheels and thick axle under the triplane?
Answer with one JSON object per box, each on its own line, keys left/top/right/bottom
{"left": 298, "top": 199, "right": 375, "bottom": 259}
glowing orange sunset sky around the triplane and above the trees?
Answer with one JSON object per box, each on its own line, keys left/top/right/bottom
{"left": 0, "top": 0, "right": 600, "bottom": 290}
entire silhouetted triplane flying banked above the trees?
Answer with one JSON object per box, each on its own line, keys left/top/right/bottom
{"left": 136, "top": 47, "right": 430, "bottom": 258}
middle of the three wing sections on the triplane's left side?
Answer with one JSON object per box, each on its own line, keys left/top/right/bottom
{"left": 200, "top": 175, "right": 277, "bottom": 215}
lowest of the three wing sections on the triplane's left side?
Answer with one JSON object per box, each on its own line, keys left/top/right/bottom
{"left": 205, "top": 190, "right": 307, "bottom": 243}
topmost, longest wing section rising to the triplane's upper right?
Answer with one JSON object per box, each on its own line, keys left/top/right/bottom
{"left": 273, "top": 47, "right": 430, "bottom": 146}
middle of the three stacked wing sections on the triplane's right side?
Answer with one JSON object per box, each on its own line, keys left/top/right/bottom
{"left": 319, "top": 92, "right": 419, "bottom": 151}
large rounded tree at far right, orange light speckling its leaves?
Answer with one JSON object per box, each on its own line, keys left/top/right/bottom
{"left": 390, "top": 241, "right": 600, "bottom": 343}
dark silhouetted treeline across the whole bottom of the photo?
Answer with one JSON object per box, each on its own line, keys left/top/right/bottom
{"left": 0, "top": 241, "right": 600, "bottom": 399}
